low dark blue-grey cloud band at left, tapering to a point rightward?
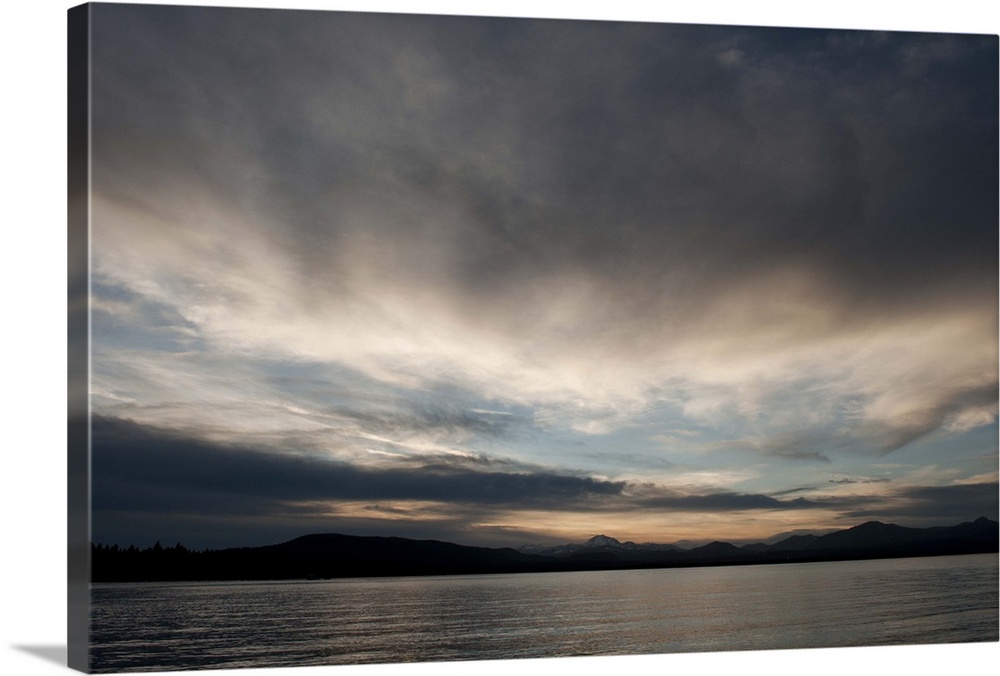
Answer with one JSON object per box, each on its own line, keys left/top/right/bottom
{"left": 92, "top": 417, "right": 624, "bottom": 514}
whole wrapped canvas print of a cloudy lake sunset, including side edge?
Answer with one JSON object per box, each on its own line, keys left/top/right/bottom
{"left": 69, "top": 3, "right": 1000, "bottom": 673}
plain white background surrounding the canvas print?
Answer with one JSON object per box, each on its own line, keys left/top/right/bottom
{"left": 0, "top": 0, "right": 1000, "bottom": 676}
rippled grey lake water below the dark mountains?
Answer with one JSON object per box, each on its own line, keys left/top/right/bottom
{"left": 91, "top": 554, "right": 1000, "bottom": 671}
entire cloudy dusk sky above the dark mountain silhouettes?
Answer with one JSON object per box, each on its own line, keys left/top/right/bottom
{"left": 80, "top": 5, "right": 1000, "bottom": 548}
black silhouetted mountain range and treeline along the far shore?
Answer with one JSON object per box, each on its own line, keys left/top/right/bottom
{"left": 91, "top": 517, "right": 1000, "bottom": 582}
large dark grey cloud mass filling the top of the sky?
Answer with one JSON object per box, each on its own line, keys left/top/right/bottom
{"left": 95, "top": 7, "right": 997, "bottom": 286}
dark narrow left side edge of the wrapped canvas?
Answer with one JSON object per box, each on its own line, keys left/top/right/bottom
{"left": 66, "top": 5, "right": 91, "bottom": 672}
